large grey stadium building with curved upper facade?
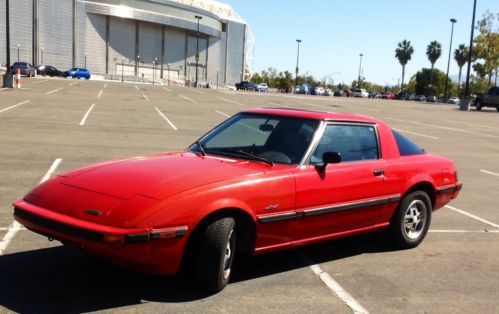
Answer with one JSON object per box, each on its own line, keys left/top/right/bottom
{"left": 0, "top": 0, "right": 253, "bottom": 85}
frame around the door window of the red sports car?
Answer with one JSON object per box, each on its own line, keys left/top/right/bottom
{"left": 300, "top": 120, "right": 383, "bottom": 166}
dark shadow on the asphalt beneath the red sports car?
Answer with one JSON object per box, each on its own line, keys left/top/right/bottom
{"left": 0, "top": 233, "right": 392, "bottom": 313}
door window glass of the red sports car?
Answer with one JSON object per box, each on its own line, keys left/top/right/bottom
{"left": 311, "top": 124, "right": 379, "bottom": 164}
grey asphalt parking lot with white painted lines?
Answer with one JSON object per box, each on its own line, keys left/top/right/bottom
{"left": 0, "top": 78, "right": 499, "bottom": 313}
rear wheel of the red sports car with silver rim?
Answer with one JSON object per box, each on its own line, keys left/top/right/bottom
{"left": 389, "top": 191, "right": 432, "bottom": 249}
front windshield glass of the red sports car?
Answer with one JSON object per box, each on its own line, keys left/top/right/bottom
{"left": 189, "top": 113, "right": 319, "bottom": 164}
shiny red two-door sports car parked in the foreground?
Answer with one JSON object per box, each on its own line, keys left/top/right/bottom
{"left": 14, "top": 109, "right": 461, "bottom": 291}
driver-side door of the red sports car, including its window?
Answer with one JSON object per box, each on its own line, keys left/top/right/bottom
{"left": 293, "top": 123, "right": 400, "bottom": 242}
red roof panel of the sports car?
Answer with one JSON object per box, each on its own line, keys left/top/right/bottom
{"left": 243, "top": 108, "right": 380, "bottom": 123}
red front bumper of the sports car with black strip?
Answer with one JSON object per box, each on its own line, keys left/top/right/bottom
{"left": 13, "top": 200, "right": 187, "bottom": 274}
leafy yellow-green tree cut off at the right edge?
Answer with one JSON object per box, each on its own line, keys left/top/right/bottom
{"left": 472, "top": 11, "right": 499, "bottom": 86}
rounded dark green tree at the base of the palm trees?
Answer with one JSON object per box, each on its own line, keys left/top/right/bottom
{"left": 411, "top": 68, "right": 456, "bottom": 97}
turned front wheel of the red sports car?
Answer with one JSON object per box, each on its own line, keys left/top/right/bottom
{"left": 196, "top": 217, "right": 236, "bottom": 293}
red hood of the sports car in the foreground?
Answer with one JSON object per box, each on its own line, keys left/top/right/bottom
{"left": 61, "top": 152, "right": 268, "bottom": 201}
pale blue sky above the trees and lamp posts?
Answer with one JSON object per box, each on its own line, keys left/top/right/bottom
{"left": 229, "top": 0, "right": 499, "bottom": 85}
